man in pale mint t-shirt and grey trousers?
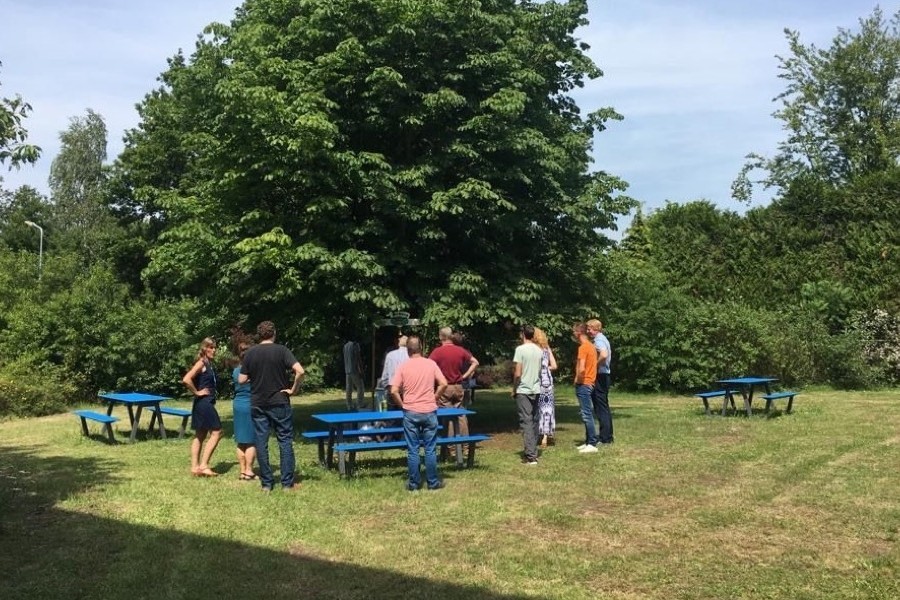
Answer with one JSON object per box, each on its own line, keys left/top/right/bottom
{"left": 512, "top": 325, "right": 543, "bottom": 465}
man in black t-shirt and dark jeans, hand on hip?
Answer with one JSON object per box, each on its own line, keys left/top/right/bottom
{"left": 238, "top": 321, "right": 305, "bottom": 492}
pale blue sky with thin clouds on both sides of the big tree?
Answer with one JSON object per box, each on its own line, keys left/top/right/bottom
{"left": 0, "top": 0, "right": 884, "bottom": 237}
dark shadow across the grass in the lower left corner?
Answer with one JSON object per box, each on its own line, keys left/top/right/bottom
{"left": 0, "top": 447, "right": 526, "bottom": 600}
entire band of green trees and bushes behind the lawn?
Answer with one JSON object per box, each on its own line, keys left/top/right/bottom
{"left": 0, "top": 0, "right": 900, "bottom": 413}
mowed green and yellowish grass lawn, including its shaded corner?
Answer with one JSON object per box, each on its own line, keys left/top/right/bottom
{"left": 0, "top": 387, "right": 900, "bottom": 600}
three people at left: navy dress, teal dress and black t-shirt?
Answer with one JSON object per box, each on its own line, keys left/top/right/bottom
{"left": 182, "top": 321, "right": 305, "bottom": 492}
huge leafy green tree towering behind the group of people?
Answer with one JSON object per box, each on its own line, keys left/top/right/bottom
{"left": 115, "top": 0, "right": 630, "bottom": 352}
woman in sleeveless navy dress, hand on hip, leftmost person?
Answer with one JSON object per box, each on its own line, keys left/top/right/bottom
{"left": 182, "top": 338, "right": 222, "bottom": 477}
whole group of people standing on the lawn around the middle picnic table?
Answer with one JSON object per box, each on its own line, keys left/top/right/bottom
{"left": 183, "top": 319, "right": 613, "bottom": 491}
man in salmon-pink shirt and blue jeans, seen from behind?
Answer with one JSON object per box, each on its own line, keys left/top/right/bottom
{"left": 391, "top": 335, "right": 447, "bottom": 492}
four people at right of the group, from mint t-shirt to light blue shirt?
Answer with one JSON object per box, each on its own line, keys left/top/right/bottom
{"left": 512, "top": 319, "right": 613, "bottom": 465}
